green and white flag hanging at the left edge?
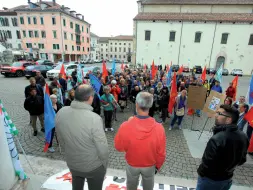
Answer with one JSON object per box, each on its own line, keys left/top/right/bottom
{"left": 0, "top": 100, "right": 27, "bottom": 180}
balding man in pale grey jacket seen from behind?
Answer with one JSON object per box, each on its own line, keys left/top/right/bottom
{"left": 55, "top": 84, "right": 109, "bottom": 190}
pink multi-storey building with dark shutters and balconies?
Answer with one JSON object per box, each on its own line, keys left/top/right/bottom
{"left": 15, "top": 0, "right": 90, "bottom": 62}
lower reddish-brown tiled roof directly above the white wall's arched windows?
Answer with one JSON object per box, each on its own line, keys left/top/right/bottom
{"left": 134, "top": 13, "right": 253, "bottom": 22}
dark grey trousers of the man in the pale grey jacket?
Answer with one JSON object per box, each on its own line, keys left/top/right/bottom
{"left": 70, "top": 166, "right": 106, "bottom": 190}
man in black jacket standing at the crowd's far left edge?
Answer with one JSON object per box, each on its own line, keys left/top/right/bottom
{"left": 24, "top": 88, "right": 45, "bottom": 136}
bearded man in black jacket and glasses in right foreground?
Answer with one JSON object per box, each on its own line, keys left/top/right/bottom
{"left": 196, "top": 105, "right": 249, "bottom": 190}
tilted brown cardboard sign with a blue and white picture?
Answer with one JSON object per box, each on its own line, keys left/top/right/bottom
{"left": 203, "top": 90, "right": 226, "bottom": 117}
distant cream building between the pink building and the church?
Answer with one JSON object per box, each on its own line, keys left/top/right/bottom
{"left": 99, "top": 35, "right": 133, "bottom": 62}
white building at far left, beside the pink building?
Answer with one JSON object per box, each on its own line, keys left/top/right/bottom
{"left": 0, "top": 8, "right": 21, "bottom": 49}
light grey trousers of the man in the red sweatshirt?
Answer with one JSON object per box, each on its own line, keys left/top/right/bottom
{"left": 126, "top": 164, "right": 155, "bottom": 190}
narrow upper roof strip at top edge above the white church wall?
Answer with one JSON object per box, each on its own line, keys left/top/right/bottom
{"left": 141, "top": 0, "right": 253, "bottom": 5}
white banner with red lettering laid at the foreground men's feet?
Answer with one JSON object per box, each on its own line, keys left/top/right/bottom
{"left": 41, "top": 170, "right": 195, "bottom": 190}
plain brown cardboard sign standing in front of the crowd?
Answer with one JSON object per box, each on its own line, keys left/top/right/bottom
{"left": 187, "top": 85, "right": 207, "bottom": 110}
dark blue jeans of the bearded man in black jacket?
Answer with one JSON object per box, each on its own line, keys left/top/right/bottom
{"left": 196, "top": 176, "right": 232, "bottom": 190}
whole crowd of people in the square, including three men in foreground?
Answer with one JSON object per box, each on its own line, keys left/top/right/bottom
{"left": 24, "top": 64, "right": 253, "bottom": 190}
